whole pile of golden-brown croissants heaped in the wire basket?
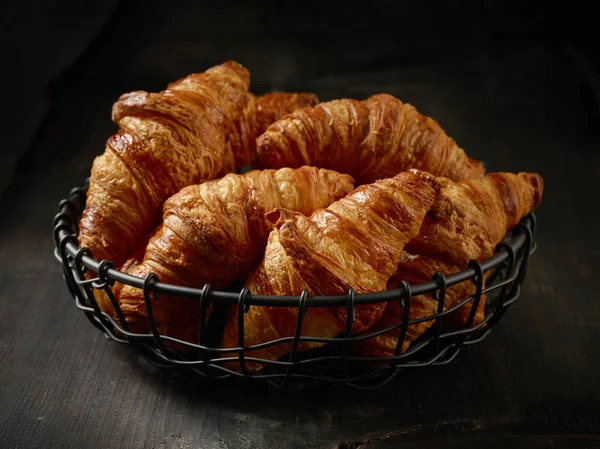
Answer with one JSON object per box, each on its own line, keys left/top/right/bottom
{"left": 71, "top": 57, "right": 543, "bottom": 369}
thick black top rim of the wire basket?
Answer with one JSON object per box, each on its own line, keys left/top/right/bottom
{"left": 53, "top": 178, "right": 536, "bottom": 307}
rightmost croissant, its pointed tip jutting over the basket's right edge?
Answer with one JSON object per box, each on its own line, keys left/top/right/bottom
{"left": 354, "top": 173, "right": 543, "bottom": 357}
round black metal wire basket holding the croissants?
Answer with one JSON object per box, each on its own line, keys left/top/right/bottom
{"left": 53, "top": 178, "right": 536, "bottom": 390}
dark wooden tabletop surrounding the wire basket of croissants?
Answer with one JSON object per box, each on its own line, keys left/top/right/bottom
{"left": 0, "top": 1, "right": 600, "bottom": 449}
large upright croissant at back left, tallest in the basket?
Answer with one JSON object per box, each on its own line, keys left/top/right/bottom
{"left": 79, "top": 61, "right": 317, "bottom": 267}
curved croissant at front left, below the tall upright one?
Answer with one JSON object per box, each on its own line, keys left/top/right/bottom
{"left": 119, "top": 167, "right": 354, "bottom": 342}
